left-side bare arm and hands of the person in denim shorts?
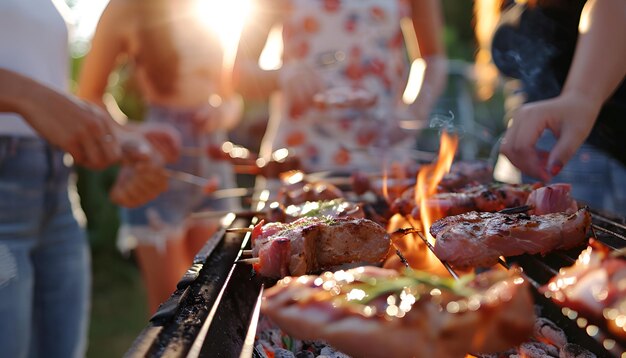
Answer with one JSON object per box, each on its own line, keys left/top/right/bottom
{"left": 78, "top": 0, "right": 180, "bottom": 207}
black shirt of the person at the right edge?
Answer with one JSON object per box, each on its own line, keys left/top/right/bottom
{"left": 492, "top": 0, "right": 626, "bottom": 165}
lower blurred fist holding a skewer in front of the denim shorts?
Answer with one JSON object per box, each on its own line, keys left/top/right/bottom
{"left": 109, "top": 161, "right": 168, "bottom": 208}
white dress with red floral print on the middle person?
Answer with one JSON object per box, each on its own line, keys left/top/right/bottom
{"left": 264, "top": 0, "right": 413, "bottom": 171}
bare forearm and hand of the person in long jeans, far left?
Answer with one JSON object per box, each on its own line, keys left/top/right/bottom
{"left": 0, "top": 68, "right": 120, "bottom": 168}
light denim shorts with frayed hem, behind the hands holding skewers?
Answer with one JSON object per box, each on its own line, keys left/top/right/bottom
{"left": 118, "top": 105, "right": 239, "bottom": 252}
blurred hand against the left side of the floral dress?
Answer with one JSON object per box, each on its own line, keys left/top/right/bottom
{"left": 279, "top": 63, "right": 325, "bottom": 113}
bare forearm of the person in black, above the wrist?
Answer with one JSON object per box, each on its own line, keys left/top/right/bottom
{"left": 563, "top": 0, "right": 626, "bottom": 110}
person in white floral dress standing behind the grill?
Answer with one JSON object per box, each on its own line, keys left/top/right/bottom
{"left": 236, "top": 0, "right": 447, "bottom": 171}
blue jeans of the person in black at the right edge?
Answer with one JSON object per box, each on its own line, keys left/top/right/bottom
{"left": 523, "top": 131, "right": 626, "bottom": 217}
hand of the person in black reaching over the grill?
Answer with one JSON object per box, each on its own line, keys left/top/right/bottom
{"left": 500, "top": 94, "right": 600, "bottom": 182}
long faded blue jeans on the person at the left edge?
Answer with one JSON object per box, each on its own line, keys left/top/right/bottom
{"left": 0, "top": 137, "right": 90, "bottom": 358}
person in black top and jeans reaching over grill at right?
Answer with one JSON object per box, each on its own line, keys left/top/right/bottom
{"left": 482, "top": 0, "right": 626, "bottom": 215}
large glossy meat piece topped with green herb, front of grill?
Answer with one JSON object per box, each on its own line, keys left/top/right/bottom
{"left": 261, "top": 267, "right": 535, "bottom": 358}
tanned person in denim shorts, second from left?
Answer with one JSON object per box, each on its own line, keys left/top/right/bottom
{"left": 78, "top": 0, "right": 242, "bottom": 313}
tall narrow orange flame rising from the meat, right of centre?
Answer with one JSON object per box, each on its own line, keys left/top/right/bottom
{"left": 415, "top": 132, "right": 459, "bottom": 244}
